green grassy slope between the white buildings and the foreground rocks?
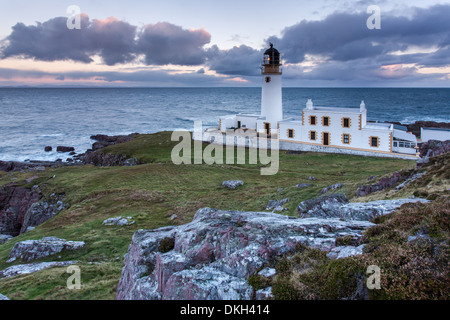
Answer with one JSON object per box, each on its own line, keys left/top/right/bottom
{"left": 0, "top": 132, "right": 414, "bottom": 299}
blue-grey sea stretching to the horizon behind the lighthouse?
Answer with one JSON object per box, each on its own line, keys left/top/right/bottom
{"left": 0, "top": 88, "right": 450, "bottom": 161}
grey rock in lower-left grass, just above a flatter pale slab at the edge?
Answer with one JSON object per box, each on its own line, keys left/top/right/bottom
{"left": 7, "top": 237, "right": 85, "bottom": 263}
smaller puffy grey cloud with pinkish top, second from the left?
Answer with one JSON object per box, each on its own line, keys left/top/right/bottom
{"left": 137, "top": 22, "right": 211, "bottom": 65}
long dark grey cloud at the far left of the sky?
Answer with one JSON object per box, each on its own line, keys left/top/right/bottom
{"left": 2, "top": 15, "right": 136, "bottom": 65}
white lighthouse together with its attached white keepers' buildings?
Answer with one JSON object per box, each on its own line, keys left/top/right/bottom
{"left": 207, "top": 44, "right": 417, "bottom": 159}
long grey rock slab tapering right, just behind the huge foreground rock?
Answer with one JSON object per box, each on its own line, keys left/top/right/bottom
{"left": 297, "top": 194, "right": 429, "bottom": 221}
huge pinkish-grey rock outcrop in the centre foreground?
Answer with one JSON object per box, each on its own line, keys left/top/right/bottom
{"left": 117, "top": 208, "right": 374, "bottom": 300}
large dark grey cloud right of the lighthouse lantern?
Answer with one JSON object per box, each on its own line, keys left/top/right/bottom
{"left": 268, "top": 5, "right": 450, "bottom": 64}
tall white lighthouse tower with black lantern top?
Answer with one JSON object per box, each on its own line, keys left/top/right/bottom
{"left": 261, "top": 43, "right": 283, "bottom": 134}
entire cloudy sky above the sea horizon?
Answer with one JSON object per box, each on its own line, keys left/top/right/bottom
{"left": 0, "top": 0, "right": 450, "bottom": 87}
